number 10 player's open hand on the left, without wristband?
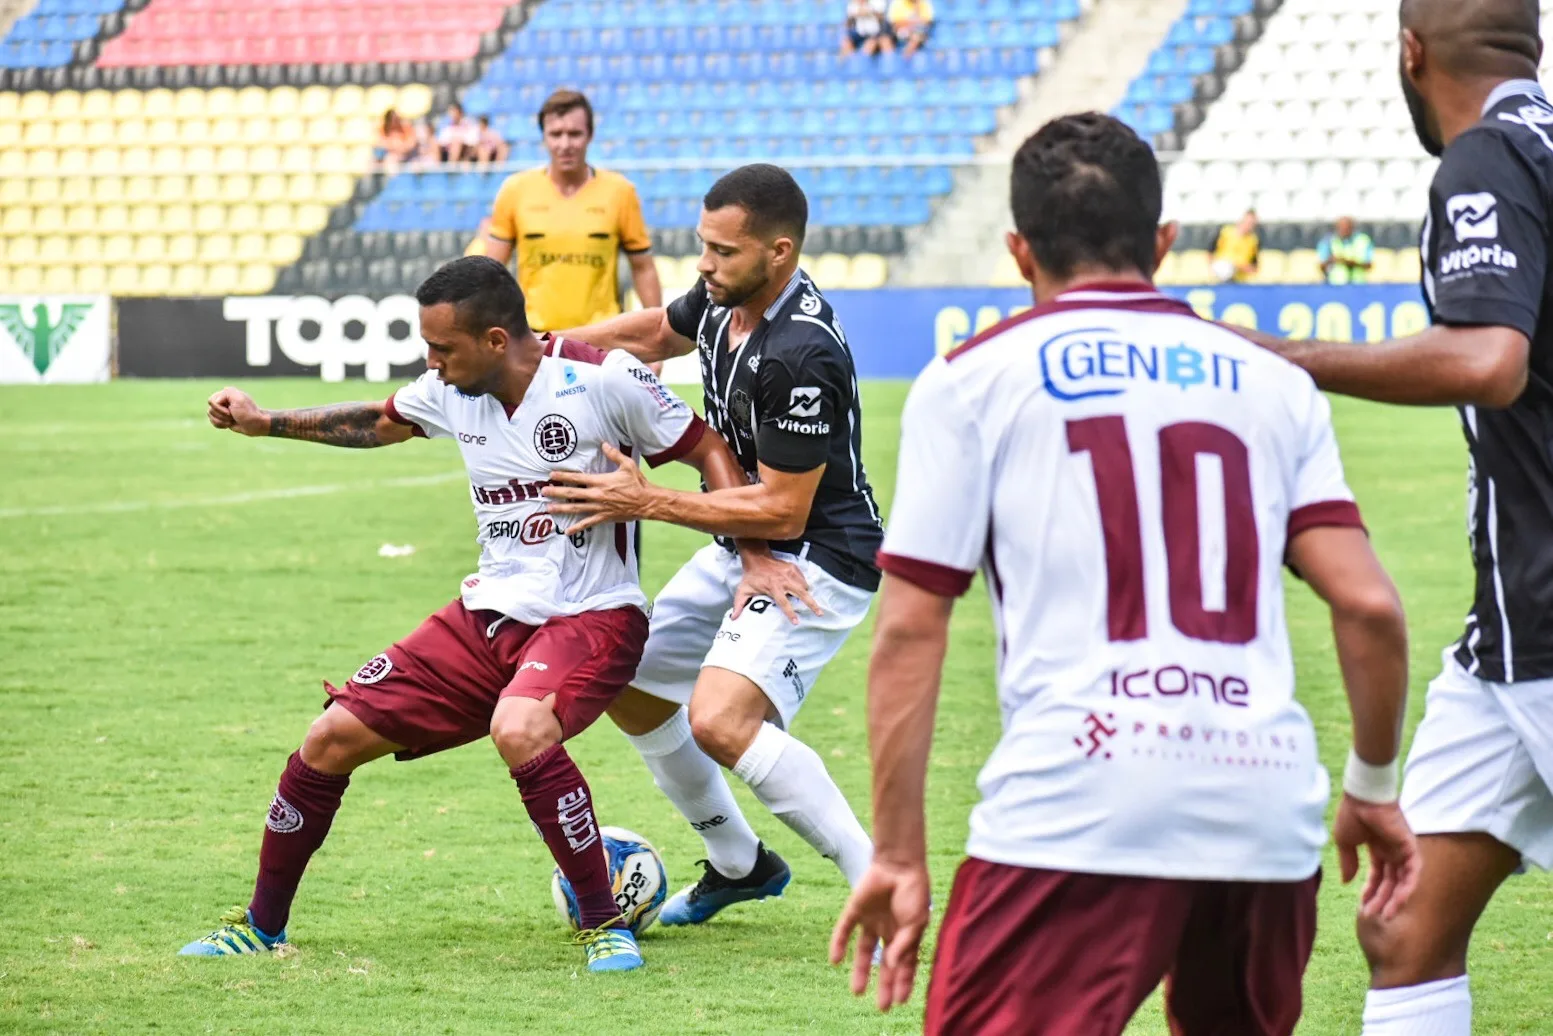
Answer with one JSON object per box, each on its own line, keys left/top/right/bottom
{"left": 831, "top": 856, "right": 932, "bottom": 1011}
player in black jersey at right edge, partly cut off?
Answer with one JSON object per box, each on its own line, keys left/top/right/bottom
{"left": 1259, "top": 0, "right": 1553, "bottom": 1036}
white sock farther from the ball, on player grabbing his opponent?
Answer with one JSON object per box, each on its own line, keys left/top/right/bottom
{"left": 733, "top": 722, "right": 873, "bottom": 885}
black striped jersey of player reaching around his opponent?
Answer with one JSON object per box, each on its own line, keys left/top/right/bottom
{"left": 668, "top": 270, "right": 884, "bottom": 590}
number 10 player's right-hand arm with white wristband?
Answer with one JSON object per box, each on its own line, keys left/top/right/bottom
{"left": 1289, "top": 527, "right": 1419, "bottom": 920}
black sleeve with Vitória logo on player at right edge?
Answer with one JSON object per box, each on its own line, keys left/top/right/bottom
{"left": 1429, "top": 129, "right": 1548, "bottom": 339}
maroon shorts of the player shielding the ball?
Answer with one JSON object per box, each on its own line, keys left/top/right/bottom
{"left": 323, "top": 601, "right": 648, "bottom": 760}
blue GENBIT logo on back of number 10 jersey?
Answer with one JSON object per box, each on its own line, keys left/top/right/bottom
{"left": 1039, "top": 328, "right": 1246, "bottom": 402}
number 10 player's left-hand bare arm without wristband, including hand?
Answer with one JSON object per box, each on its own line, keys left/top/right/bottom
{"left": 831, "top": 573, "right": 954, "bottom": 1011}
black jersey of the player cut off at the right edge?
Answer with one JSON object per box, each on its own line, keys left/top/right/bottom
{"left": 1421, "top": 81, "right": 1553, "bottom": 683}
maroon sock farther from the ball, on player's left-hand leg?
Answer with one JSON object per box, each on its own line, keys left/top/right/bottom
{"left": 248, "top": 752, "right": 351, "bottom": 935}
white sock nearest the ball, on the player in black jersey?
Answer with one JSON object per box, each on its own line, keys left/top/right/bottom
{"left": 627, "top": 708, "right": 759, "bottom": 878}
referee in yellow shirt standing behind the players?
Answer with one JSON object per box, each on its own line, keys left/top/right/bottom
{"left": 471, "top": 90, "right": 663, "bottom": 331}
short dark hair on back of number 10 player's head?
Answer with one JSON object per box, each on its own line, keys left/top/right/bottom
{"left": 1009, "top": 112, "right": 1163, "bottom": 276}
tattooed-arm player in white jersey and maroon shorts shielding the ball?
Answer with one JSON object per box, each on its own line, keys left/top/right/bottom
{"left": 182, "top": 258, "right": 744, "bottom": 971}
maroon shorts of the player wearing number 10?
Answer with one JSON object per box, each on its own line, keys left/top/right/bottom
{"left": 926, "top": 859, "right": 1322, "bottom": 1036}
